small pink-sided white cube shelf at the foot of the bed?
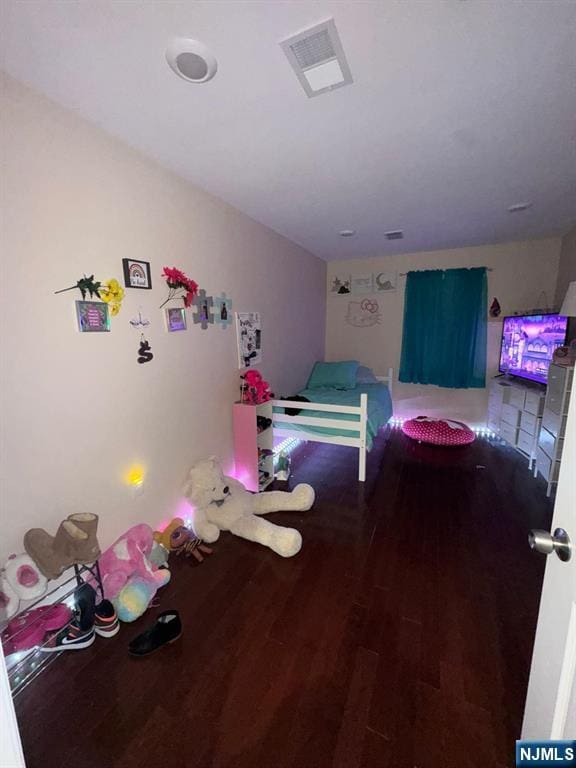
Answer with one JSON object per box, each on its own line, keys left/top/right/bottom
{"left": 234, "top": 403, "right": 274, "bottom": 492}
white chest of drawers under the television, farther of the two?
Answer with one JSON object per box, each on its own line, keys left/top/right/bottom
{"left": 486, "top": 377, "right": 546, "bottom": 469}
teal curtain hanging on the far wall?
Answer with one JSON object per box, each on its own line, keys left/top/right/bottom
{"left": 399, "top": 267, "right": 488, "bottom": 389}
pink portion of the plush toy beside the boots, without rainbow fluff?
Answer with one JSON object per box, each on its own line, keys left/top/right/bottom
{"left": 99, "top": 523, "right": 170, "bottom": 600}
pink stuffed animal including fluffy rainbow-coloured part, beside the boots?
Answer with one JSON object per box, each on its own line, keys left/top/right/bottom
{"left": 98, "top": 523, "right": 170, "bottom": 621}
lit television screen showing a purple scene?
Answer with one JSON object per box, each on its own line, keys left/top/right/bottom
{"left": 499, "top": 315, "right": 568, "bottom": 384}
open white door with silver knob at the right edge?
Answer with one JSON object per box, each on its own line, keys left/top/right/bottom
{"left": 522, "top": 379, "right": 576, "bottom": 740}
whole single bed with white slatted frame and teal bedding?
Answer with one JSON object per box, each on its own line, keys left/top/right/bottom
{"left": 272, "top": 368, "right": 393, "bottom": 482}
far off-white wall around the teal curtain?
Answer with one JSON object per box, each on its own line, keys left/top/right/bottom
{"left": 326, "top": 238, "right": 560, "bottom": 424}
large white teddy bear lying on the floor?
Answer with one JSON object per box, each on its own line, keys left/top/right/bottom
{"left": 184, "top": 457, "right": 314, "bottom": 557}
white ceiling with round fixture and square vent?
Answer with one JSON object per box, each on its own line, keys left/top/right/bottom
{"left": 0, "top": 0, "right": 576, "bottom": 260}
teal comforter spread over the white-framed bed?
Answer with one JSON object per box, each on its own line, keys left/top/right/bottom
{"left": 274, "top": 384, "right": 392, "bottom": 450}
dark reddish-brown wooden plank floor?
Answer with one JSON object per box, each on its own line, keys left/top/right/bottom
{"left": 16, "top": 430, "right": 551, "bottom": 768}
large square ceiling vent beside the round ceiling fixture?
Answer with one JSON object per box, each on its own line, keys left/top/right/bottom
{"left": 280, "top": 19, "right": 352, "bottom": 96}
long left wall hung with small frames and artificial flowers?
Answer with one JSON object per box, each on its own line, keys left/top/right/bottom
{"left": 0, "top": 76, "right": 326, "bottom": 563}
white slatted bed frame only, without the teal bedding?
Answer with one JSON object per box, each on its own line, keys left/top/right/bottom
{"left": 272, "top": 368, "right": 394, "bottom": 483}
